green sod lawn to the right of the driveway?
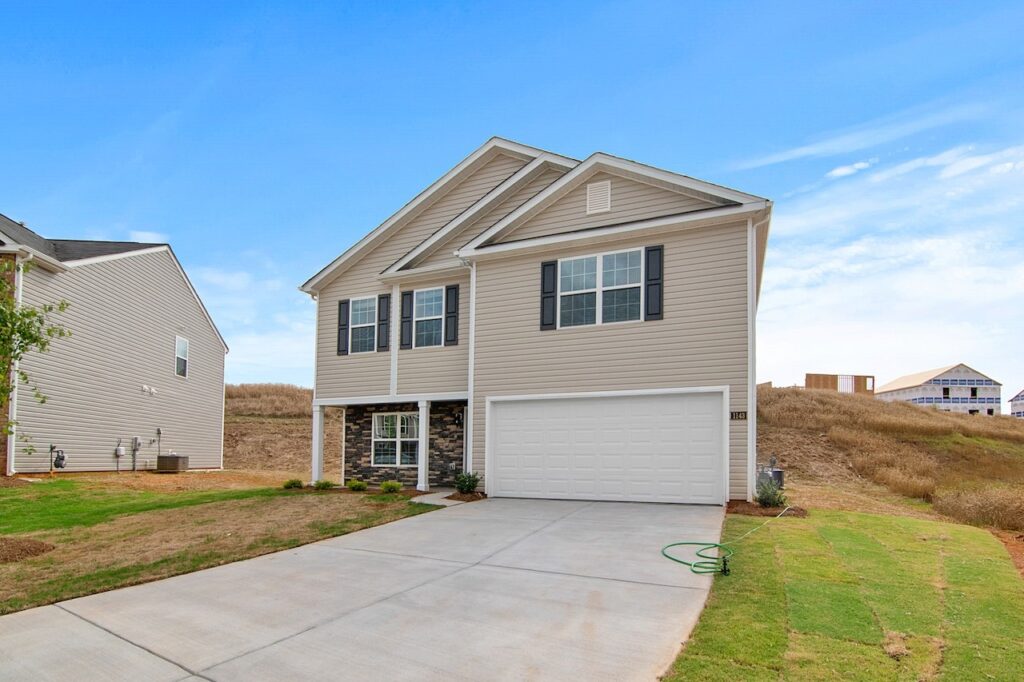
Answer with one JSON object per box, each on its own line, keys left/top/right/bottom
{"left": 666, "top": 511, "right": 1024, "bottom": 681}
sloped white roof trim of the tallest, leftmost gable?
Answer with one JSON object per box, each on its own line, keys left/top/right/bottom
{"left": 299, "top": 137, "right": 554, "bottom": 294}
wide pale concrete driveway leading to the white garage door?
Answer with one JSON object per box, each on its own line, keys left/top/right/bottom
{"left": 0, "top": 499, "right": 723, "bottom": 682}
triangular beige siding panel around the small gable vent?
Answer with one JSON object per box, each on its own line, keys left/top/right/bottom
{"left": 500, "top": 172, "right": 716, "bottom": 242}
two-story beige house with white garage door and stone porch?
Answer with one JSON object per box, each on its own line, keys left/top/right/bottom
{"left": 301, "top": 138, "right": 771, "bottom": 504}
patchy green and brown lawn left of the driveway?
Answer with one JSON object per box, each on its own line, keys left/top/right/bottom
{"left": 0, "top": 479, "right": 439, "bottom": 614}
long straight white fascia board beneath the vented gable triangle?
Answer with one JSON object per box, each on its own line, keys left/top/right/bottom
{"left": 456, "top": 201, "right": 770, "bottom": 260}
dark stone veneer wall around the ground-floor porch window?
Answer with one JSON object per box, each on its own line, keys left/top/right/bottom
{"left": 345, "top": 402, "right": 466, "bottom": 487}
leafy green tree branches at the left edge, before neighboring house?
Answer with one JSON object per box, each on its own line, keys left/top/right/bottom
{"left": 0, "top": 258, "right": 71, "bottom": 434}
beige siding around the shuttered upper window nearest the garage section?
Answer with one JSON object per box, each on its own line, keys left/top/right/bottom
{"left": 398, "top": 275, "right": 469, "bottom": 393}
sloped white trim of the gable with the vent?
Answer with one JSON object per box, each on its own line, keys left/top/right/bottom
{"left": 459, "top": 152, "right": 766, "bottom": 255}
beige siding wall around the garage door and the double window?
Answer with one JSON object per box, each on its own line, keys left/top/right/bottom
{"left": 473, "top": 222, "right": 749, "bottom": 499}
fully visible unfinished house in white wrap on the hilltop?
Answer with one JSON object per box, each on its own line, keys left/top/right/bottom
{"left": 874, "top": 364, "right": 1002, "bottom": 416}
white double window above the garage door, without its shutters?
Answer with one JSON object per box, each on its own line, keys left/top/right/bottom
{"left": 558, "top": 249, "right": 643, "bottom": 327}
